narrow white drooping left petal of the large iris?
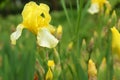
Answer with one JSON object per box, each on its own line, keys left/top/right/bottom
{"left": 10, "top": 24, "right": 24, "bottom": 45}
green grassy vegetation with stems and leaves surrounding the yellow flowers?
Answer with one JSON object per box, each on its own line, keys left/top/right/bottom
{"left": 0, "top": 0, "right": 120, "bottom": 80}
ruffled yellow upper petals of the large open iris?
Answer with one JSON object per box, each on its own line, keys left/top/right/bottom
{"left": 22, "top": 1, "right": 51, "bottom": 34}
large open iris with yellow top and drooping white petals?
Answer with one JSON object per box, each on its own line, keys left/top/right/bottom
{"left": 10, "top": 1, "right": 58, "bottom": 48}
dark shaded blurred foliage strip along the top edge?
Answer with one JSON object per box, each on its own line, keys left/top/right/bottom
{"left": 0, "top": 0, "right": 120, "bottom": 15}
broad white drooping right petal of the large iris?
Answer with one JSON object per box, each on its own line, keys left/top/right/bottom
{"left": 37, "top": 28, "right": 58, "bottom": 48}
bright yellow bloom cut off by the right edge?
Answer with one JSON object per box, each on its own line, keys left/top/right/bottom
{"left": 111, "top": 27, "right": 120, "bottom": 56}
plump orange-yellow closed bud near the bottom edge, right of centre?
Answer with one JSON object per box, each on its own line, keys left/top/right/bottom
{"left": 88, "top": 59, "right": 97, "bottom": 78}
